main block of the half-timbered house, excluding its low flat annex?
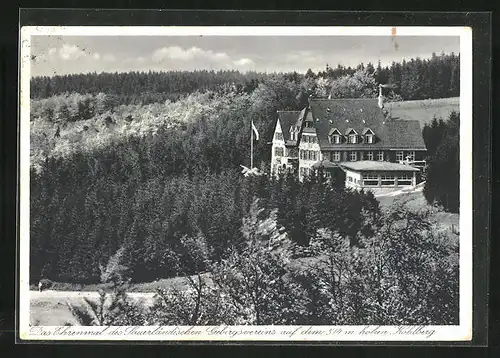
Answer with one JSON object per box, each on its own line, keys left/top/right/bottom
{"left": 271, "top": 91, "right": 426, "bottom": 186}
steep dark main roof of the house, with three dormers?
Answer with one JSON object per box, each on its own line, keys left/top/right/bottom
{"left": 310, "top": 98, "right": 426, "bottom": 150}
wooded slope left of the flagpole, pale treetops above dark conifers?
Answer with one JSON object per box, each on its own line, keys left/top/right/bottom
{"left": 30, "top": 76, "right": 310, "bottom": 282}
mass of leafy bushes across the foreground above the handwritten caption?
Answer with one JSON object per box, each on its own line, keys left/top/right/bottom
{"left": 68, "top": 202, "right": 458, "bottom": 325}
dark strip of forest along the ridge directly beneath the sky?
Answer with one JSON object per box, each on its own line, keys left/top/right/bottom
{"left": 30, "top": 53, "right": 460, "bottom": 104}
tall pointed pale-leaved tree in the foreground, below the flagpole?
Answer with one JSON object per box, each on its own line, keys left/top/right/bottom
{"left": 207, "top": 200, "right": 301, "bottom": 325}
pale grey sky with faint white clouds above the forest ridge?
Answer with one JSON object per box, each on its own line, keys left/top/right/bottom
{"left": 31, "top": 35, "right": 460, "bottom": 76}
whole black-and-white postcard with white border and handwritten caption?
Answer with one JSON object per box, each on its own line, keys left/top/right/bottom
{"left": 19, "top": 26, "right": 472, "bottom": 341}
